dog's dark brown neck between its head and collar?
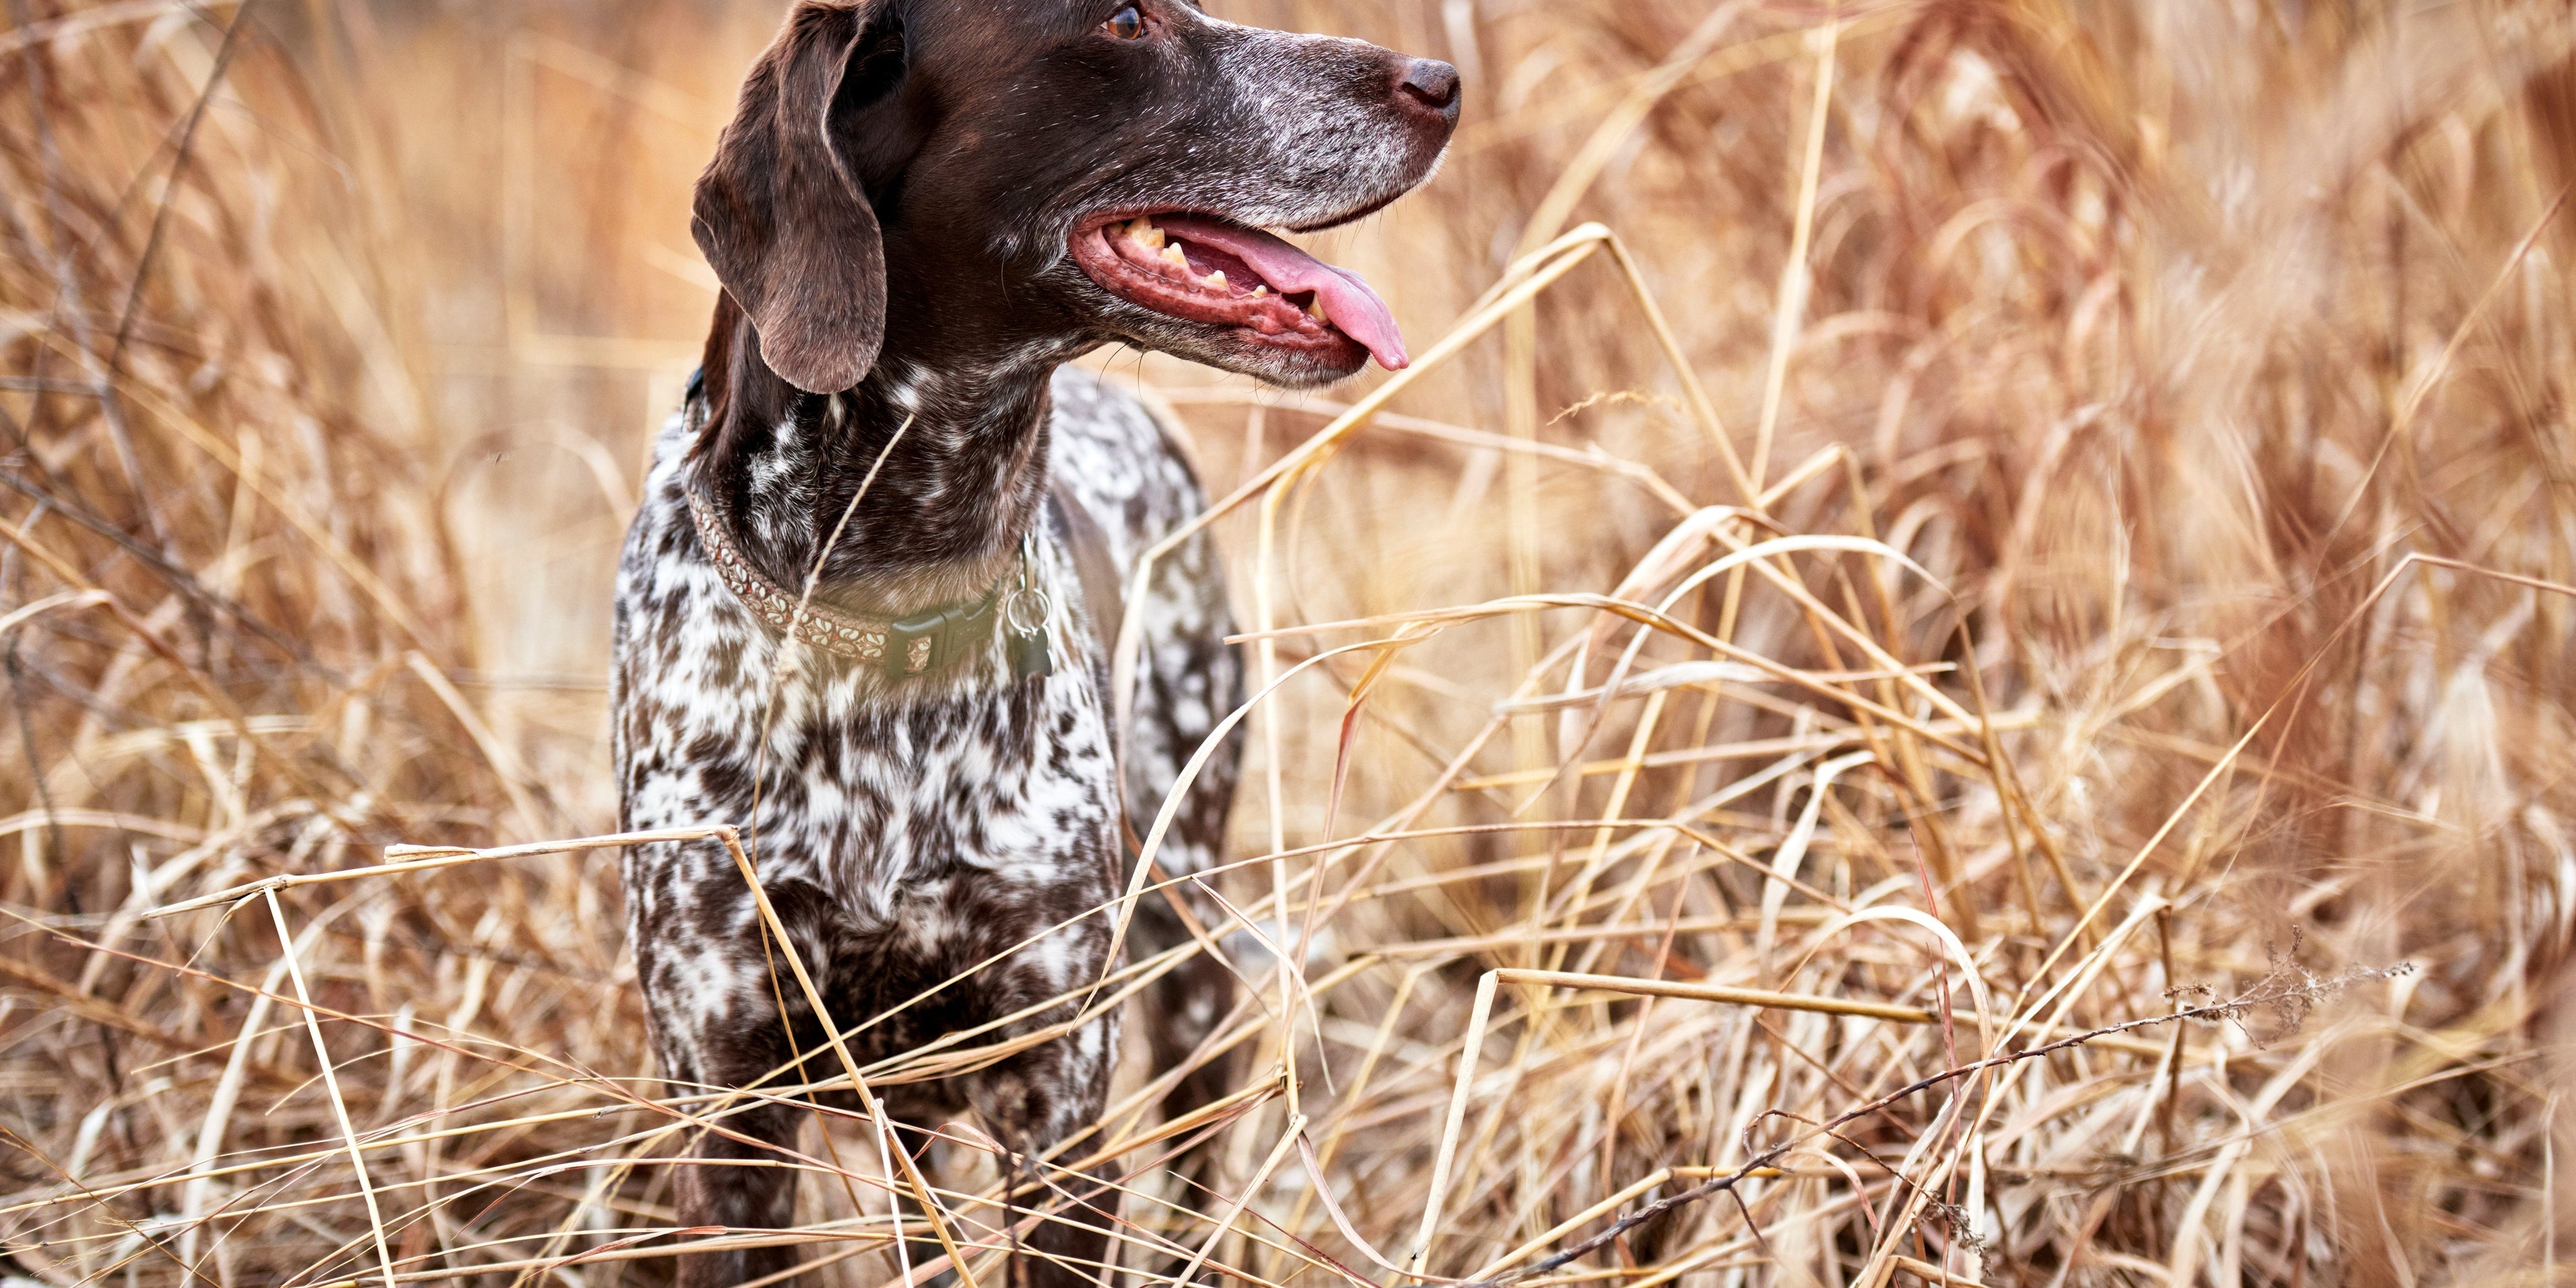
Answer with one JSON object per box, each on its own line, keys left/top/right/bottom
{"left": 696, "top": 299, "right": 1074, "bottom": 616}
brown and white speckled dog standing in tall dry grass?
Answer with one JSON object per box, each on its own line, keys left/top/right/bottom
{"left": 613, "top": 0, "right": 1458, "bottom": 1285}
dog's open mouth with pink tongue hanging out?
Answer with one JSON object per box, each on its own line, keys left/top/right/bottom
{"left": 1072, "top": 214, "right": 1407, "bottom": 371}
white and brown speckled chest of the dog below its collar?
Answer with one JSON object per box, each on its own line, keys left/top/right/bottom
{"left": 613, "top": 422, "right": 1115, "bottom": 937}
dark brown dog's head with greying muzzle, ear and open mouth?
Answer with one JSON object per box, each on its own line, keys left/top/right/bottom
{"left": 693, "top": 0, "right": 1458, "bottom": 391}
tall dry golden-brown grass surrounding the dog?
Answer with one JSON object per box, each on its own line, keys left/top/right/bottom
{"left": 0, "top": 0, "right": 2576, "bottom": 1288}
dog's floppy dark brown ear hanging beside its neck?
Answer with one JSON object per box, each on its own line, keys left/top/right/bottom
{"left": 688, "top": 0, "right": 904, "bottom": 394}
